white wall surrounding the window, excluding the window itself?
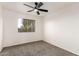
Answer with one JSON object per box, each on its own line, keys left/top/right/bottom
{"left": 3, "top": 9, "right": 43, "bottom": 47}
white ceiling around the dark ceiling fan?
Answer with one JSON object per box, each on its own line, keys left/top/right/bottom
{"left": 0, "top": 2, "right": 71, "bottom": 16}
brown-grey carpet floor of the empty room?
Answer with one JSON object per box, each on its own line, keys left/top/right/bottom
{"left": 0, "top": 41, "right": 76, "bottom": 56}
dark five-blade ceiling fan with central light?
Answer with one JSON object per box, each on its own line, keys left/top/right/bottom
{"left": 24, "top": 2, "right": 48, "bottom": 15}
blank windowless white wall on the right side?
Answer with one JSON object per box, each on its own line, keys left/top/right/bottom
{"left": 44, "top": 3, "right": 79, "bottom": 55}
